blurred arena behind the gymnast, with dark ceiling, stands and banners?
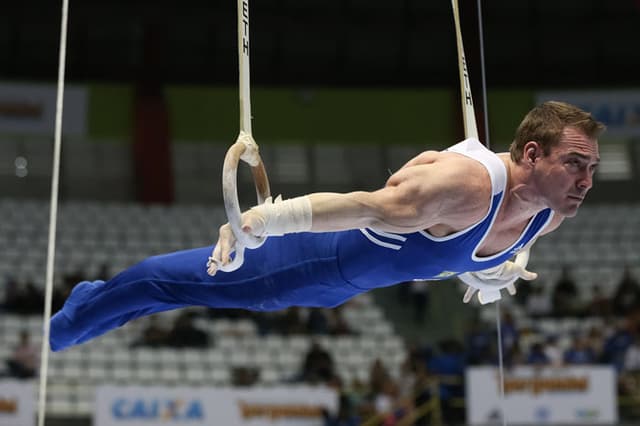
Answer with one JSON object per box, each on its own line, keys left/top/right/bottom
{"left": 0, "top": 0, "right": 640, "bottom": 426}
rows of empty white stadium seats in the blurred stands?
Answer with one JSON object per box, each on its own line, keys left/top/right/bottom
{"left": 0, "top": 199, "right": 640, "bottom": 416}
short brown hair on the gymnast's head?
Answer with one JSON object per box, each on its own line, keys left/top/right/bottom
{"left": 509, "top": 101, "right": 606, "bottom": 163}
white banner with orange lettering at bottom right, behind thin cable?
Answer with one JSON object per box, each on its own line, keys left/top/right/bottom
{"left": 466, "top": 366, "right": 618, "bottom": 425}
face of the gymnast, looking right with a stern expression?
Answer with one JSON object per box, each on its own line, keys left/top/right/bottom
{"left": 534, "top": 127, "right": 600, "bottom": 217}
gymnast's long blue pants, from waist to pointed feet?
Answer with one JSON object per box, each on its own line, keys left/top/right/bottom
{"left": 50, "top": 233, "right": 366, "bottom": 351}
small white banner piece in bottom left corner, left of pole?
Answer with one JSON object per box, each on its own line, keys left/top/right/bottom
{"left": 0, "top": 380, "right": 36, "bottom": 426}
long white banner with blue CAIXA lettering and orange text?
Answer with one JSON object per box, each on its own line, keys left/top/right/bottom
{"left": 93, "top": 386, "right": 338, "bottom": 426}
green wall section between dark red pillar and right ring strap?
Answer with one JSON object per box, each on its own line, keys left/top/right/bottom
{"left": 166, "top": 87, "right": 453, "bottom": 144}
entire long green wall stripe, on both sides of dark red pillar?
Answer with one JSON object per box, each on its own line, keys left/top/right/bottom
{"left": 89, "top": 84, "right": 534, "bottom": 150}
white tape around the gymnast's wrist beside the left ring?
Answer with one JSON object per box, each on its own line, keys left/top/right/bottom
{"left": 251, "top": 195, "right": 312, "bottom": 235}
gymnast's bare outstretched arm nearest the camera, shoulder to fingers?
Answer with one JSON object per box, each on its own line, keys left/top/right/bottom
{"left": 212, "top": 153, "right": 490, "bottom": 272}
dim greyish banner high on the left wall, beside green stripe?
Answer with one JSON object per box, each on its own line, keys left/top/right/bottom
{"left": 0, "top": 83, "right": 88, "bottom": 137}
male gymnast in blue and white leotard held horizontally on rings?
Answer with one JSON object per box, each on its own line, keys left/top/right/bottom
{"left": 50, "top": 102, "right": 604, "bottom": 351}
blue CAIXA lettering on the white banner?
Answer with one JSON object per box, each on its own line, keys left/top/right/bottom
{"left": 111, "top": 398, "right": 204, "bottom": 421}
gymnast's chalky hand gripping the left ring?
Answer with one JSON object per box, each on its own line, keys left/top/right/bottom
{"left": 207, "top": 209, "right": 266, "bottom": 276}
